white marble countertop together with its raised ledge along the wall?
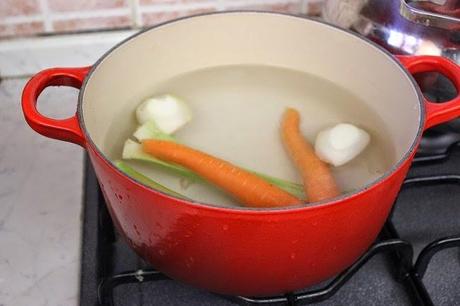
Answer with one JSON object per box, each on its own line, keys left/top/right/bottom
{"left": 0, "top": 31, "right": 135, "bottom": 306}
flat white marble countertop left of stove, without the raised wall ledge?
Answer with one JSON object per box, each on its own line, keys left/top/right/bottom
{"left": 0, "top": 79, "right": 83, "bottom": 306}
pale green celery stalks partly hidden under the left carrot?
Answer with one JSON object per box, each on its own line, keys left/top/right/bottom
{"left": 123, "top": 121, "right": 305, "bottom": 199}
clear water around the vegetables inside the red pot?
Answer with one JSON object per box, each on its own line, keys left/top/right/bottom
{"left": 104, "top": 65, "right": 397, "bottom": 206}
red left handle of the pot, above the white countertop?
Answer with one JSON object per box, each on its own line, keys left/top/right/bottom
{"left": 22, "top": 67, "right": 91, "bottom": 147}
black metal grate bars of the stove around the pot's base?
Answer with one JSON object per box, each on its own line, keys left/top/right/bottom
{"left": 91, "top": 175, "right": 460, "bottom": 306}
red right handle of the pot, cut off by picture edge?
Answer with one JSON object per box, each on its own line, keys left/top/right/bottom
{"left": 397, "top": 55, "right": 460, "bottom": 130}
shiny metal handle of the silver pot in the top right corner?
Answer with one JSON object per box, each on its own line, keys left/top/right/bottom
{"left": 399, "top": 0, "right": 460, "bottom": 30}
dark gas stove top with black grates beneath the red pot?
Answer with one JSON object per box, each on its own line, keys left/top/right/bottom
{"left": 80, "top": 79, "right": 460, "bottom": 306}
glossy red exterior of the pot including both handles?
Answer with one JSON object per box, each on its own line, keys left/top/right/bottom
{"left": 22, "top": 50, "right": 460, "bottom": 296}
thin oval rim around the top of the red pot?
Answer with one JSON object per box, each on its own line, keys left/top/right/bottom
{"left": 76, "top": 10, "right": 426, "bottom": 215}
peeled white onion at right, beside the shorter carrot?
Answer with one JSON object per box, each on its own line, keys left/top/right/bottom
{"left": 315, "top": 123, "right": 371, "bottom": 167}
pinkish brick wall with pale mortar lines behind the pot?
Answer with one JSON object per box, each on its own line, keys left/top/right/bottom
{"left": 0, "top": 0, "right": 323, "bottom": 38}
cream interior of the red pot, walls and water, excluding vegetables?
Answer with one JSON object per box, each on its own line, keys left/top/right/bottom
{"left": 82, "top": 12, "right": 421, "bottom": 205}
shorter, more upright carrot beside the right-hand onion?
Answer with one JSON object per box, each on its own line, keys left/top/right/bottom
{"left": 281, "top": 108, "right": 340, "bottom": 202}
